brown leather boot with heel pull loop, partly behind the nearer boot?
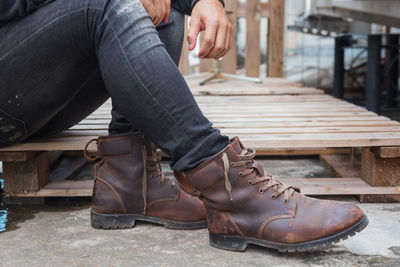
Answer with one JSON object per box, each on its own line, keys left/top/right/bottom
{"left": 85, "top": 134, "right": 207, "bottom": 229}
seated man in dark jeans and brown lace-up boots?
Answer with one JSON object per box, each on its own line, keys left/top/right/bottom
{"left": 0, "top": 0, "right": 368, "bottom": 251}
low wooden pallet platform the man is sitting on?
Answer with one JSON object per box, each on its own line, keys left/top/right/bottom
{"left": 0, "top": 79, "right": 400, "bottom": 199}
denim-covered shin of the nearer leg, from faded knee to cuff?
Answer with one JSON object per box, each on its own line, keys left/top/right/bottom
{"left": 96, "top": 1, "right": 228, "bottom": 170}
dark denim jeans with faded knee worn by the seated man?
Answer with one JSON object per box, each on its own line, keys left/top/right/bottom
{"left": 0, "top": 0, "right": 228, "bottom": 171}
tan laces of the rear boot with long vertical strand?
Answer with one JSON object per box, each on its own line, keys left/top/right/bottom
{"left": 141, "top": 145, "right": 175, "bottom": 214}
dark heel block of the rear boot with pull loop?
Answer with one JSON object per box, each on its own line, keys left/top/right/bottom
{"left": 90, "top": 211, "right": 136, "bottom": 230}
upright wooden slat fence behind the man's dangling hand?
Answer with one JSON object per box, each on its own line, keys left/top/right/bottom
{"left": 179, "top": 0, "right": 285, "bottom": 77}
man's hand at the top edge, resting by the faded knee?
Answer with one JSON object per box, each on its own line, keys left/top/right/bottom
{"left": 140, "top": 0, "right": 171, "bottom": 26}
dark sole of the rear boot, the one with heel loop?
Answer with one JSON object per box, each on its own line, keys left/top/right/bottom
{"left": 90, "top": 211, "right": 207, "bottom": 230}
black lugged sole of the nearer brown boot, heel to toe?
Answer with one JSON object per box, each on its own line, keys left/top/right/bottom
{"left": 210, "top": 215, "right": 368, "bottom": 252}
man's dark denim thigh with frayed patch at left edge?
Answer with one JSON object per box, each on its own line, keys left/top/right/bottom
{"left": 0, "top": 1, "right": 109, "bottom": 145}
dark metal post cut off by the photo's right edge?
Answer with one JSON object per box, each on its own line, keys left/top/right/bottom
{"left": 385, "top": 34, "right": 400, "bottom": 107}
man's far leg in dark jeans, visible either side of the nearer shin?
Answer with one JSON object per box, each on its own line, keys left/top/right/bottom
{"left": 108, "top": 7, "right": 185, "bottom": 135}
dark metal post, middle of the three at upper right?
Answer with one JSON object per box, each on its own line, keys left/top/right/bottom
{"left": 365, "top": 34, "right": 382, "bottom": 113}
